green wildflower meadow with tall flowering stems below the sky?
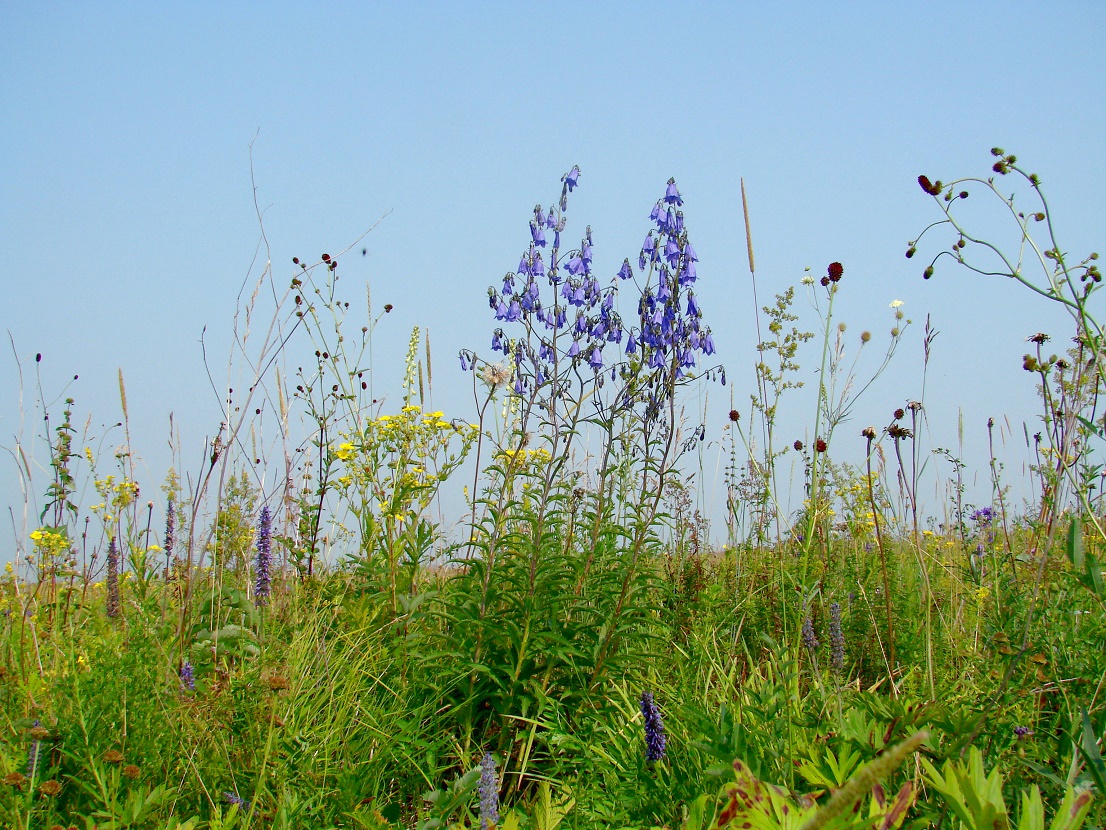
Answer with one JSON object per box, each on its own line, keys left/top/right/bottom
{"left": 0, "top": 148, "right": 1106, "bottom": 830}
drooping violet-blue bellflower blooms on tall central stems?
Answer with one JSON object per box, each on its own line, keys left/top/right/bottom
{"left": 460, "top": 167, "right": 726, "bottom": 429}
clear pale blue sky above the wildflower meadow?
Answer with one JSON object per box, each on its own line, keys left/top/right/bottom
{"left": 0, "top": 0, "right": 1106, "bottom": 553}
